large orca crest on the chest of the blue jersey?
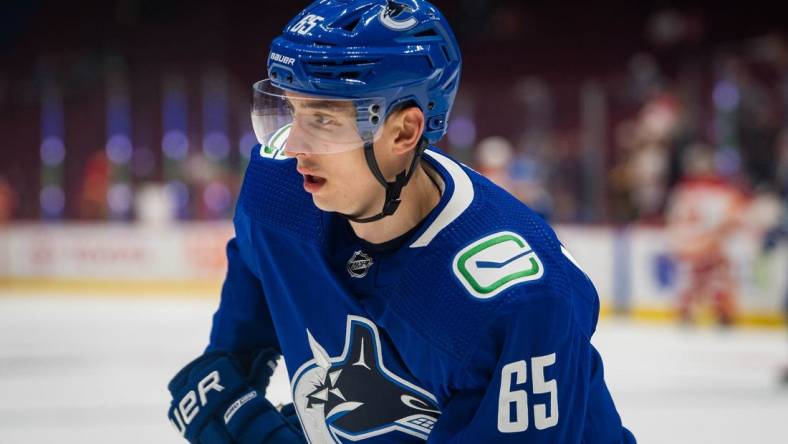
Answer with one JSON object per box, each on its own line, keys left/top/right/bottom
{"left": 292, "top": 316, "right": 440, "bottom": 444}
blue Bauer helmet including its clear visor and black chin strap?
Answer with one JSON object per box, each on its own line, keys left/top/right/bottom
{"left": 252, "top": 0, "right": 462, "bottom": 223}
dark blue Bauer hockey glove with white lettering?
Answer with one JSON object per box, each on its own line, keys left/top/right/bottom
{"left": 168, "top": 351, "right": 305, "bottom": 444}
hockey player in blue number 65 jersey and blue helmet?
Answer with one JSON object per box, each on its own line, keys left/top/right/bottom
{"left": 169, "top": 0, "right": 634, "bottom": 444}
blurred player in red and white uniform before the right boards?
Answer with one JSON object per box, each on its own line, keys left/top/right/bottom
{"left": 667, "top": 144, "right": 746, "bottom": 325}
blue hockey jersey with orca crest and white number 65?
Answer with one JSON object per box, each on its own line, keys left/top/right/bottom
{"left": 208, "top": 146, "right": 634, "bottom": 443}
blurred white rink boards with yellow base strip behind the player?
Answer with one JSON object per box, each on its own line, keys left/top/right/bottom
{"left": 0, "top": 222, "right": 788, "bottom": 325}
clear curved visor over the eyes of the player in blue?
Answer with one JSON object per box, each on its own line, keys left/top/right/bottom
{"left": 252, "top": 79, "right": 386, "bottom": 154}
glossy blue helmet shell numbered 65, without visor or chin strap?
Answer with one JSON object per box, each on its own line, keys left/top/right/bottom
{"left": 264, "top": 0, "right": 461, "bottom": 143}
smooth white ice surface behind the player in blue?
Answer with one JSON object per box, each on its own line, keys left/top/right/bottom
{"left": 0, "top": 294, "right": 788, "bottom": 444}
